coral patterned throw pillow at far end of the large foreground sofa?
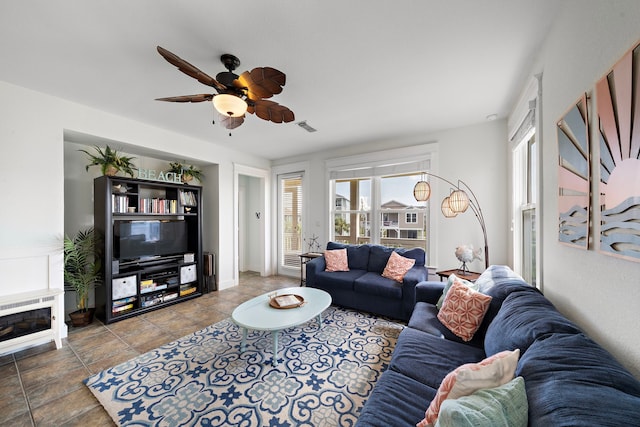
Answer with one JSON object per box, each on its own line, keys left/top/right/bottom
{"left": 438, "top": 280, "right": 491, "bottom": 341}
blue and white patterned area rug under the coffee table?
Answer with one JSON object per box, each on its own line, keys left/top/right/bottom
{"left": 85, "top": 306, "right": 403, "bottom": 427}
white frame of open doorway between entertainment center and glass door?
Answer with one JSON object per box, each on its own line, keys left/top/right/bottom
{"left": 233, "top": 163, "right": 271, "bottom": 285}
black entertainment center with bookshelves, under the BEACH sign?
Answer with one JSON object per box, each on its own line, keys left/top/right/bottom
{"left": 94, "top": 176, "right": 204, "bottom": 323}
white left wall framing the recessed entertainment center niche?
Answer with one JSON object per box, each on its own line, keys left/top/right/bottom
{"left": 0, "top": 82, "right": 269, "bottom": 344}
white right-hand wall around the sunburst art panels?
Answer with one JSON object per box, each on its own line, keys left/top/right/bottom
{"left": 520, "top": 0, "right": 640, "bottom": 377}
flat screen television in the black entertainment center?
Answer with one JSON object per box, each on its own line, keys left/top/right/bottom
{"left": 113, "top": 220, "right": 188, "bottom": 262}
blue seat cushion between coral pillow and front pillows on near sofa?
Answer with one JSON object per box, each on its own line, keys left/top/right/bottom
{"left": 389, "top": 328, "right": 486, "bottom": 390}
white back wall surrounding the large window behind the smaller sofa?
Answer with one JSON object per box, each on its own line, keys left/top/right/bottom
{"left": 274, "top": 120, "right": 511, "bottom": 271}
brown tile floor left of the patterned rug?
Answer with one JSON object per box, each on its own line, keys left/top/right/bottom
{"left": 0, "top": 273, "right": 300, "bottom": 427}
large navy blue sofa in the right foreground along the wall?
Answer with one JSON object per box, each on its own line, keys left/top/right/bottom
{"left": 356, "top": 268, "right": 640, "bottom": 427}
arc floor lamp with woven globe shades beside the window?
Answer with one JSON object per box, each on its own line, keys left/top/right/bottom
{"left": 413, "top": 172, "right": 489, "bottom": 268}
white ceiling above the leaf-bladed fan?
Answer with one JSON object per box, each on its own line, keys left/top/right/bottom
{"left": 0, "top": 0, "right": 560, "bottom": 159}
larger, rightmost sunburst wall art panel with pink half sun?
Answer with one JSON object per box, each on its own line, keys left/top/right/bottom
{"left": 596, "top": 41, "right": 640, "bottom": 261}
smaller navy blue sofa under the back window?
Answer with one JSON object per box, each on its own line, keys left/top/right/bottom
{"left": 306, "top": 242, "right": 428, "bottom": 321}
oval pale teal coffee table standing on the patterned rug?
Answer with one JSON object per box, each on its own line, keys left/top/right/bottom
{"left": 231, "top": 287, "right": 331, "bottom": 366}
